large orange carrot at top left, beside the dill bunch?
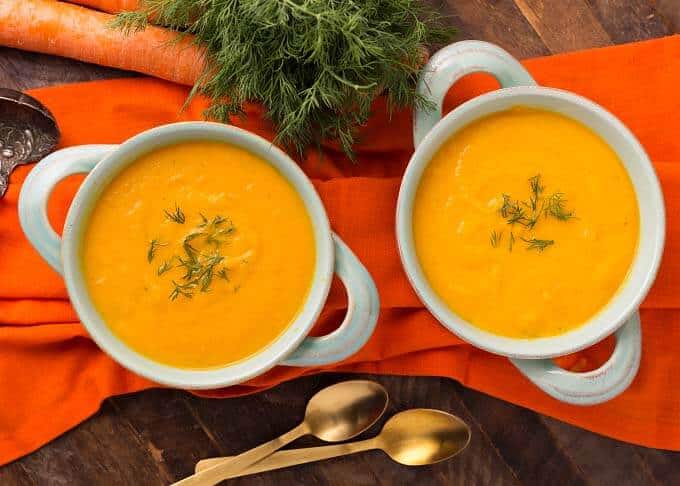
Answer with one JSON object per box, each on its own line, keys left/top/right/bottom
{"left": 0, "top": 0, "right": 204, "bottom": 85}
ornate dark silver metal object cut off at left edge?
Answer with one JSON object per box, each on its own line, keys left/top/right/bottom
{"left": 0, "top": 88, "right": 60, "bottom": 198}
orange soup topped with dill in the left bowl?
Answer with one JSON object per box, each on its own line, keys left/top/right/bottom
{"left": 82, "top": 141, "right": 316, "bottom": 368}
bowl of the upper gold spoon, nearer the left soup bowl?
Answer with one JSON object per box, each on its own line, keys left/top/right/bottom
{"left": 304, "top": 380, "right": 388, "bottom": 442}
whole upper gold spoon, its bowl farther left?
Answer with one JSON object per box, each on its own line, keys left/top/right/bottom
{"left": 175, "top": 380, "right": 388, "bottom": 486}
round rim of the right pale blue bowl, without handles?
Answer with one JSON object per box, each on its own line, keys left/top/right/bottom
{"left": 396, "top": 86, "right": 665, "bottom": 359}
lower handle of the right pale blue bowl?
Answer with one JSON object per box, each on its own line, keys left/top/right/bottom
{"left": 510, "top": 312, "right": 642, "bottom": 405}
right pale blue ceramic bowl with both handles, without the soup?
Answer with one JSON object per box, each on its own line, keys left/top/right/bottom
{"left": 397, "top": 41, "right": 665, "bottom": 405}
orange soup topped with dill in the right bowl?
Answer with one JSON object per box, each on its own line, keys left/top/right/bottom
{"left": 413, "top": 107, "right": 639, "bottom": 338}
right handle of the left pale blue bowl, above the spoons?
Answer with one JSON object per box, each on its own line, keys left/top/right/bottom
{"left": 281, "top": 234, "right": 380, "bottom": 366}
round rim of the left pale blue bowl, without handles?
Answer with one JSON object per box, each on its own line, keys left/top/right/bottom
{"left": 61, "top": 121, "right": 335, "bottom": 389}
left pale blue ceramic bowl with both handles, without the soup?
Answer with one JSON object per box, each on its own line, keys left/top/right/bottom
{"left": 19, "top": 122, "right": 380, "bottom": 389}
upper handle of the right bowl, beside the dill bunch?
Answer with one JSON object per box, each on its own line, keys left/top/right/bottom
{"left": 413, "top": 40, "right": 536, "bottom": 147}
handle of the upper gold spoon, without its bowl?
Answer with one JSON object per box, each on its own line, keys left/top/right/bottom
{"left": 173, "top": 422, "right": 309, "bottom": 486}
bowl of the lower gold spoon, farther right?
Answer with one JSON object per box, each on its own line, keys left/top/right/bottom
{"left": 377, "top": 408, "right": 471, "bottom": 466}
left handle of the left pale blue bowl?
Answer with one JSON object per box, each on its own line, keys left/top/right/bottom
{"left": 19, "top": 145, "right": 118, "bottom": 274}
